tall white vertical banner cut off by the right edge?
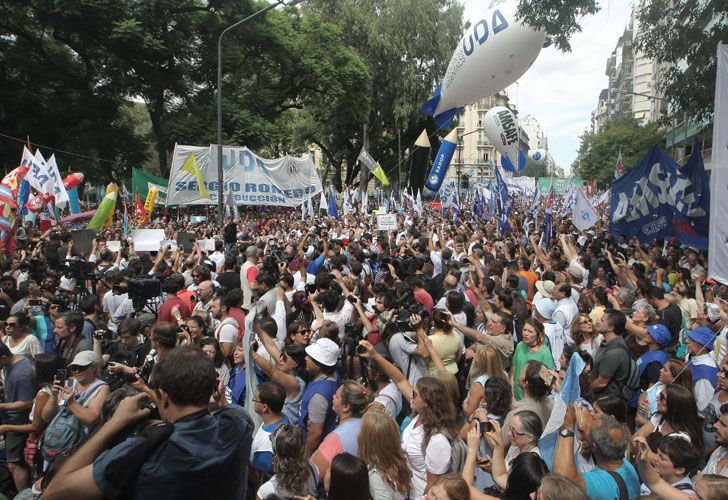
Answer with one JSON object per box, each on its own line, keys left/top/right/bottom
{"left": 708, "top": 44, "right": 728, "bottom": 284}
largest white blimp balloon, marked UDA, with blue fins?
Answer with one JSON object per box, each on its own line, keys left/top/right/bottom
{"left": 422, "top": 0, "right": 546, "bottom": 127}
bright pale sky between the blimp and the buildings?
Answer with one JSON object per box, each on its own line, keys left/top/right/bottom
{"left": 460, "top": 0, "right": 632, "bottom": 174}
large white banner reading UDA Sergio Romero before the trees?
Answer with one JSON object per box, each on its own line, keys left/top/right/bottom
{"left": 167, "top": 144, "right": 323, "bottom": 207}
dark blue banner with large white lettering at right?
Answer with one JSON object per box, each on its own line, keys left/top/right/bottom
{"left": 609, "top": 146, "right": 710, "bottom": 249}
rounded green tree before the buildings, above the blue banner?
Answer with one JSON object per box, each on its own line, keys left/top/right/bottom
{"left": 571, "top": 117, "right": 663, "bottom": 186}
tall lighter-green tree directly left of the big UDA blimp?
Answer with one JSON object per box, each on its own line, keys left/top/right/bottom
{"left": 302, "top": 0, "right": 463, "bottom": 188}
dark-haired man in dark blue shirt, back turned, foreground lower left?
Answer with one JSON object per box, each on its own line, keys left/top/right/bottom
{"left": 43, "top": 347, "right": 253, "bottom": 500}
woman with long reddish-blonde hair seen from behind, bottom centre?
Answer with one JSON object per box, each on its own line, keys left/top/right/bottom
{"left": 359, "top": 408, "right": 412, "bottom": 500}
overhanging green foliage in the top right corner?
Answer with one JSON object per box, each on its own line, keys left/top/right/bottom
{"left": 637, "top": 0, "right": 728, "bottom": 119}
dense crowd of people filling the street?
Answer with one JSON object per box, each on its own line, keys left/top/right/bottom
{"left": 0, "top": 199, "right": 728, "bottom": 500}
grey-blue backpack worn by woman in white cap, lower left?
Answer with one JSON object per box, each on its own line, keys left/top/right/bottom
{"left": 42, "top": 380, "right": 106, "bottom": 462}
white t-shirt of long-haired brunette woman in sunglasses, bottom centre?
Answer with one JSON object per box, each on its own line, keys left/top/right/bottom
{"left": 402, "top": 416, "right": 452, "bottom": 498}
